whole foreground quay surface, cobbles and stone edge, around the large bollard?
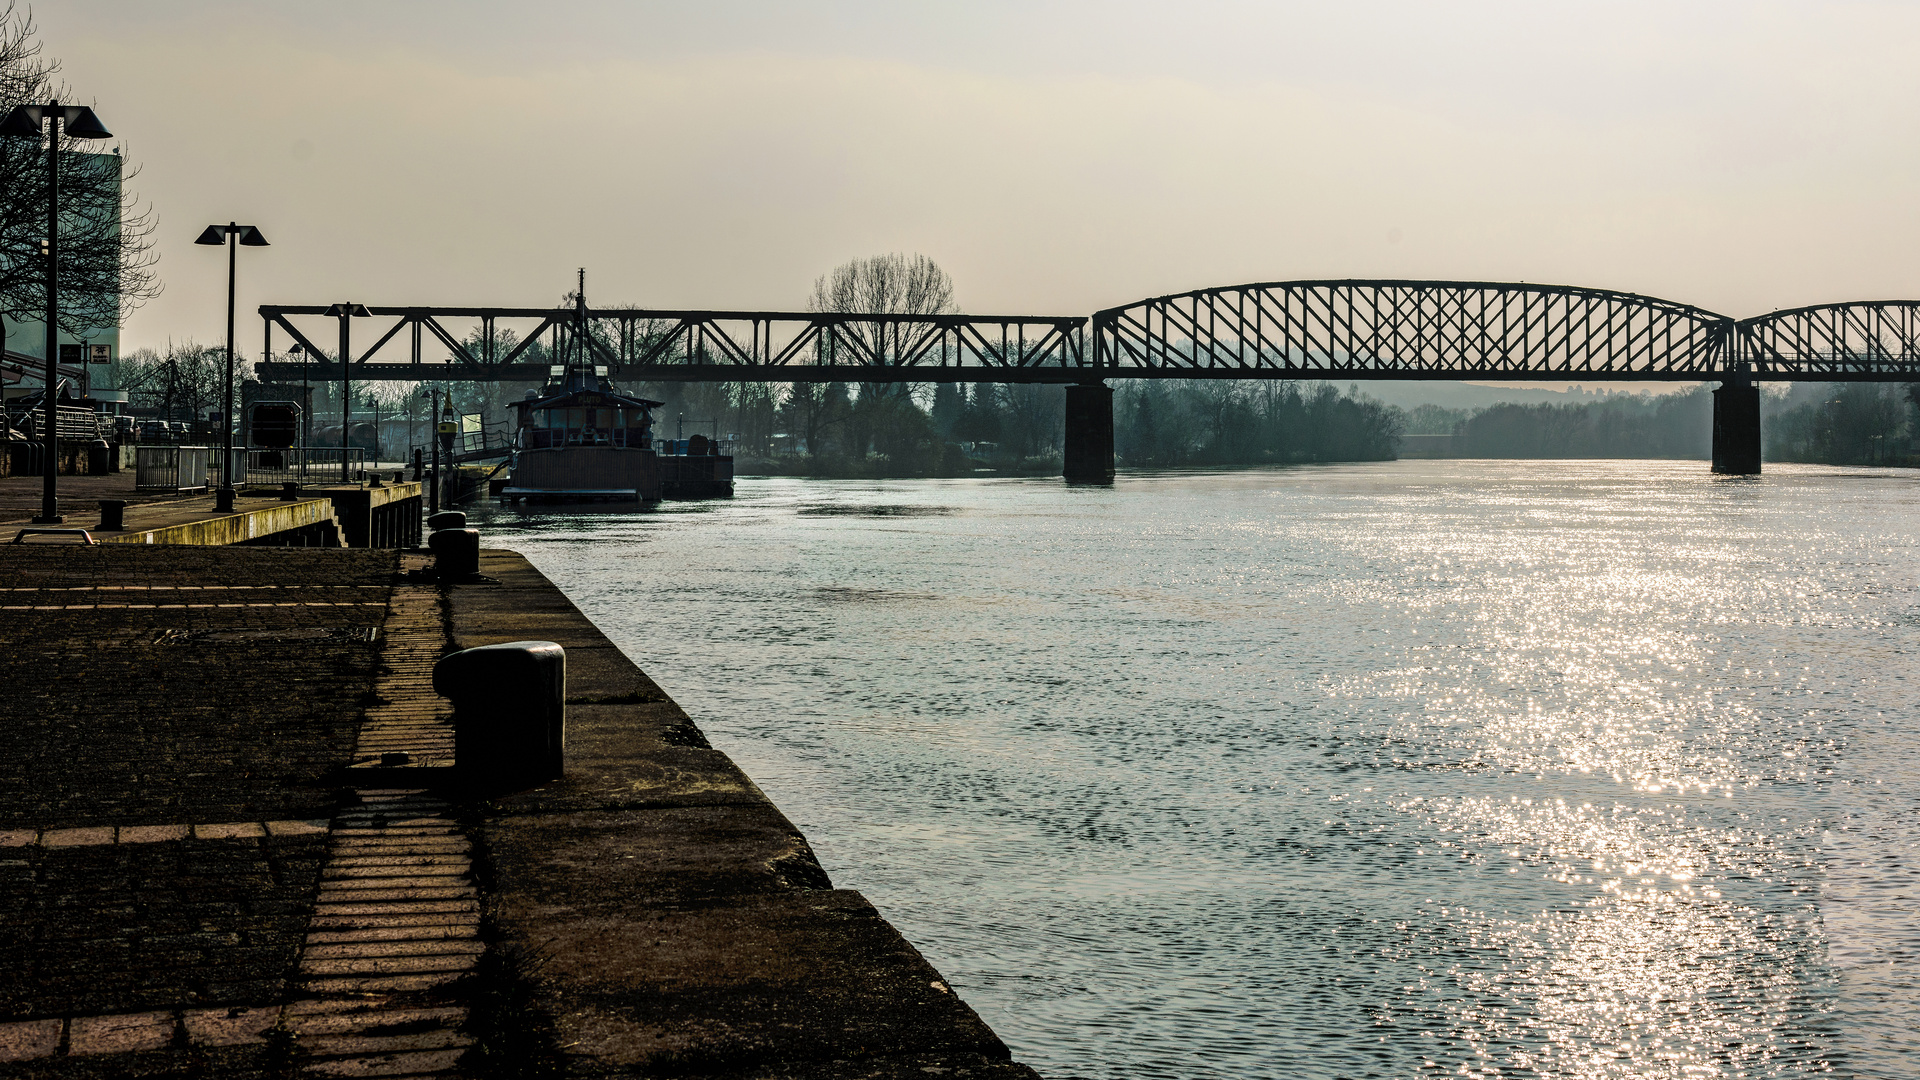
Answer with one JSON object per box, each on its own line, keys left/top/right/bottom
{"left": 0, "top": 544, "right": 1035, "bottom": 1080}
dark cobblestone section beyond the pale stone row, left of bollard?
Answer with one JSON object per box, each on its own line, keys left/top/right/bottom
{"left": 0, "top": 546, "right": 396, "bottom": 830}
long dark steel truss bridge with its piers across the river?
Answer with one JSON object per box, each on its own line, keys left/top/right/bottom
{"left": 259, "top": 281, "right": 1920, "bottom": 482}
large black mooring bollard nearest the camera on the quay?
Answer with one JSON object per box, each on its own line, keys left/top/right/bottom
{"left": 434, "top": 638, "right": 566, "bottom": 790}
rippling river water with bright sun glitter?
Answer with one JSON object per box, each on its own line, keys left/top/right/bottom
{"left": 468, "top": 461, "right": 1920, "bottom": 1080}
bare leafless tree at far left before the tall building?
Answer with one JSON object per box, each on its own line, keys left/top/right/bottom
{"left": 0, "top": 0, "right": 161, "bottom": 357}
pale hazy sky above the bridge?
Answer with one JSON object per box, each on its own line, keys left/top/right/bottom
{"left": 35, "top": 0, "right": 1920, "bottom": 350}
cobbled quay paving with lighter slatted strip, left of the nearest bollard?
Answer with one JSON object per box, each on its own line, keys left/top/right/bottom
{"left": 0, "top": 548, "right": 484, "bottom": 1080}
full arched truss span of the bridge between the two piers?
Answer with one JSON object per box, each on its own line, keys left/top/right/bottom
{"left": 1092, "top": 279, "right": 1736, "bottom": 380}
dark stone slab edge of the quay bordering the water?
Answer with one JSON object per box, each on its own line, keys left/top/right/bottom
{"left": 445, "top": 550, "right": 1037, "bottom": 1080}
